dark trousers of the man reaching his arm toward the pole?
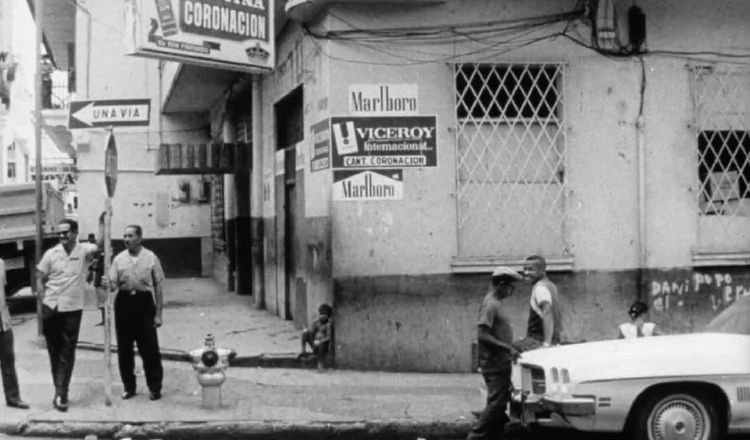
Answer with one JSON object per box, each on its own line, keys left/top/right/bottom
{"left": 42, "top": 306, "right": 83, "bottom": 401}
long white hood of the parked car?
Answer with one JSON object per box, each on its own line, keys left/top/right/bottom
{"left": 520, "top": 333, "right": 750, "bottom": 383}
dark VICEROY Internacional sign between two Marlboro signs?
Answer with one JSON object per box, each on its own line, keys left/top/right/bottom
{"left": 331, "top": 116, "right": 437, "bottom": 169}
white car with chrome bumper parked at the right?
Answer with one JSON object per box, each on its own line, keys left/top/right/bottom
{"left": 511, "top": 297, "right": 750, "bottom": 440}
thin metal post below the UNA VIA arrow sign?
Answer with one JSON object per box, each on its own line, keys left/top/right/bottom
{"left": 103, "top": 127, "right": 117, "bottom": 406}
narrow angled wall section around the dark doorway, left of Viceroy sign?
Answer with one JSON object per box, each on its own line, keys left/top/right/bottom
{"left": 260, "top": 23, "right": 333, "bottom": 327}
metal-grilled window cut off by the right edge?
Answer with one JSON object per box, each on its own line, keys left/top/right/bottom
{"left": 690, "top": 66, "right": 750, "bottom": 251}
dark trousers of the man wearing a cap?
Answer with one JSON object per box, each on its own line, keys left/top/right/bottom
{"left": 466, "top": 365, "right": 511, "bottom": 440}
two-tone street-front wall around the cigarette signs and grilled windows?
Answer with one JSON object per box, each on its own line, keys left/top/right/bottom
{"left": 329, "top": 0, "right": 750, "bottom": 371}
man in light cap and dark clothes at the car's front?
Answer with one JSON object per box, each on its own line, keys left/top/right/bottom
{"left": 466, "top": 266, "right": 522, "bottom": 440}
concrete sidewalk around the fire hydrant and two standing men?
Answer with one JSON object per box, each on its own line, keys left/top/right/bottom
{"left": 0, "top": 279, "right": 483, "bottom": 440}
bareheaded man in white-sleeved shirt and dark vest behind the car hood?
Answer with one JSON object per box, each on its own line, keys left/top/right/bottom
{"left": 515, "top": 255, "right": 563, "bottom": 351}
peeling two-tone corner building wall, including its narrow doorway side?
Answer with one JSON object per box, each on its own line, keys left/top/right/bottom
{"left": 253, "top": 0, "right": 750, "bottom": 371}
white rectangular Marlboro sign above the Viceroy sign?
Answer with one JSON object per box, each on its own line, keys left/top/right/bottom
{"left": 349, "top": 84, "right": 419, "bottom": 116}
